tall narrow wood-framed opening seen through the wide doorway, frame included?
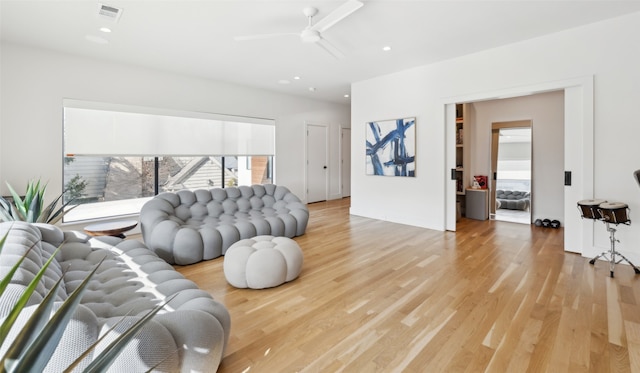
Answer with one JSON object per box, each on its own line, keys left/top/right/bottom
{"left": 490, "top": 120, "right": 532, "bottom": 224}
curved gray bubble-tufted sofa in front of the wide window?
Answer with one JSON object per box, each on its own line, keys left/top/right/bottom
{"left": 140, "top": 184, "right": 309, "bottom": 265}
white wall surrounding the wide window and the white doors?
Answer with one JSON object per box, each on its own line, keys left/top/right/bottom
{"left": 0, "top": 43, "right": 350, "bottom": 208}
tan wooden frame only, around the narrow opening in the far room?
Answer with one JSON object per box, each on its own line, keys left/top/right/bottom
{"left": 489, "top": 119, "right": 534, "bottom": 224}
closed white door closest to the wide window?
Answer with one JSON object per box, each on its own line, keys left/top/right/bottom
{"left": 306, "top": 124, "right": 329, "bottom": 203}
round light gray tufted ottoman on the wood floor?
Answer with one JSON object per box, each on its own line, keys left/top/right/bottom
{"left": 223, "top": 236, "right": 302, "bottom": 289}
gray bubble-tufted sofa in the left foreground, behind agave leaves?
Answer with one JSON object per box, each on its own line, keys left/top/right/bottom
{"left": 0, "top": 222, "right": 230, "bottom": 372}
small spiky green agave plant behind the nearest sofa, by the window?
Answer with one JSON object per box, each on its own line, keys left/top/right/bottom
{"left": 0, "top": 180, "right": 77, "bottom": 224}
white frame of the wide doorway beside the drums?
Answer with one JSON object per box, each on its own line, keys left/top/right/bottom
{"left": 440, "top": 75, "right": 597, "bottom": 256}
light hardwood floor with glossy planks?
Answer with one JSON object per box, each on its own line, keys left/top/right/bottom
{"left": 178, "top": 199, "right": 640, "bottom": 373}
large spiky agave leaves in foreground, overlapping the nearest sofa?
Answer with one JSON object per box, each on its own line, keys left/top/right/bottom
{"left": 0, "top": 225, "right": 171, "bottom": 373}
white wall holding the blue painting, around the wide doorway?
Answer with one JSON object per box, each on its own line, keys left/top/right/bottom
{"left": 351, "top": 13, "right": 640, "bottom": 262}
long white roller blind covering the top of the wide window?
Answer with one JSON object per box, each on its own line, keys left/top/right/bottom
{"left": 63, "top": 100, "right": 275, "bottom": 156}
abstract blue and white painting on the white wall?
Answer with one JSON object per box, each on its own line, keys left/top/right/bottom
{"left": 366, "top": 118, "right": 416, "bottom": 177}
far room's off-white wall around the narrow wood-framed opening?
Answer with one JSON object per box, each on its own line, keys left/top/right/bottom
{"left": 471, "top": 91, "right": 564, "bottom": 222}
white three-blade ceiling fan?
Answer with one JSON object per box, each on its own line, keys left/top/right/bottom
{"left": 234, "top": 0, "right": 364, "bottom": 59}
